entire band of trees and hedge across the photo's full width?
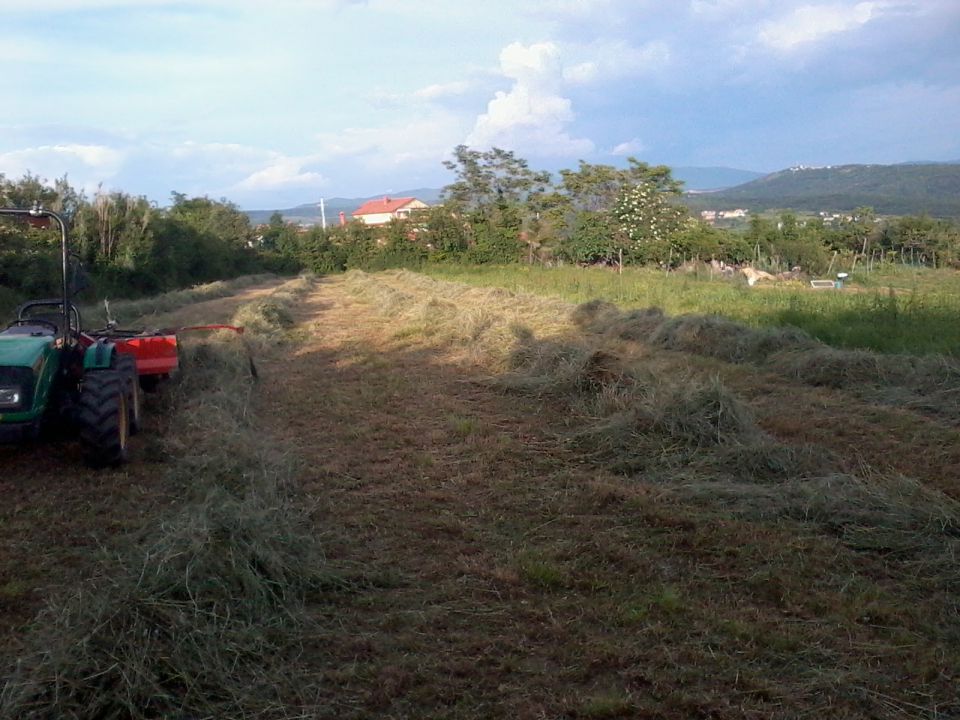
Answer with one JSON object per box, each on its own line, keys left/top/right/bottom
{"left": 0, "top": 145, "right": 960, "bottom": 314}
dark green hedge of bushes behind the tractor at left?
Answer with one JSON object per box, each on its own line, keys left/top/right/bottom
{"left": 0, "top": 174, "right": 289, "bottom": 308}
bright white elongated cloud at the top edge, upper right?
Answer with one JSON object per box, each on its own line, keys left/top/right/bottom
{"left": 759, "top": 2, "right": 888, "bottom": 51}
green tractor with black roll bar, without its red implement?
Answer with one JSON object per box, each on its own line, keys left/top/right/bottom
{"left": 0, "top": 206, "right": 140, "bottom": 467}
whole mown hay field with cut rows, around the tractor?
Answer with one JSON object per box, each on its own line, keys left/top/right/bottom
{"left": 0, "top": 270, "right": 960, "bottom": 720}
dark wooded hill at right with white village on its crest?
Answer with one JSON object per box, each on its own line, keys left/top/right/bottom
{"left": 684, "top": 163, "right": 960, "bottom": 217}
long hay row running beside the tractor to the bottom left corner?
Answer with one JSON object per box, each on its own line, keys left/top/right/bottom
{"left": 0, "top": 272, "right": 334, "bottom": 718}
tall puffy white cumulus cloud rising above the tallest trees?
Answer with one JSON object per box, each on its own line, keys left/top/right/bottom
{"left": 466, "top": 42, "right": 594, "bottom": 156}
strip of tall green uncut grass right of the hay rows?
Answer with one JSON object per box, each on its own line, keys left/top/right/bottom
{"left": 424, "top": 265, "right": 960, "bottom": 356}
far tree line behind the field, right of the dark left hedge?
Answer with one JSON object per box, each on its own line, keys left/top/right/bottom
{"left": 262, "top": 145, "right": 960, "bottom": 273}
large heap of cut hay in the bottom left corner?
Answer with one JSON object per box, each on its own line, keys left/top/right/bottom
{"left": 0, "top": 491, "right": 325, "bottom": 718}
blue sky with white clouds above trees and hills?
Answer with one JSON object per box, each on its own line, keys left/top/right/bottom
{"left": 0, "top": 0, "right": 960, "bottom": 209}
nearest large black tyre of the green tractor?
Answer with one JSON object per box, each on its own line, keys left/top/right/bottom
{"left": 78, "top": 370, "right": 130, "bottom": 468}
